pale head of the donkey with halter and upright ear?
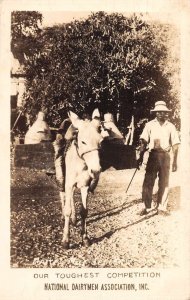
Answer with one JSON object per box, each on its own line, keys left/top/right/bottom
{"left": 69, "top": 112, "right": 103, "bottom": 178}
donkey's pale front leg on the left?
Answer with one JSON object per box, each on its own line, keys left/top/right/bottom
{"left": 62, "top": 187, "right": 73, "bottom": 249}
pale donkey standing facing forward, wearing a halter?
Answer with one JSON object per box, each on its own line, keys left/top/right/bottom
{"left": 61, "top": 112, "right": 103, "bottom": 249}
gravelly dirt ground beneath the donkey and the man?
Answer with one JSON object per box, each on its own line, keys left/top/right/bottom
{"left": 11, "top": 165, "right": 181, "bottom": 268}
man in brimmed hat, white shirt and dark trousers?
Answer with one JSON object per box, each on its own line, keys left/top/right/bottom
{"left": 138, "top": 101, "right": 180, "bottom": 216}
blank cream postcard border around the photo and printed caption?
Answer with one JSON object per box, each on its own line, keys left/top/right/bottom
{"left": 0, "top": 0, "right": 190, "bottom": 300}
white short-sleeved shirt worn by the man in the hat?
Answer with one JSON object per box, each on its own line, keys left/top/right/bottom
{"left": 140, "top": 118, "right": 180, "bottom": 151}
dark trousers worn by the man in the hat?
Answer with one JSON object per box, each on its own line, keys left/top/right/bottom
{"left": 142, "top": 150, "right": 170, "bottom": 208}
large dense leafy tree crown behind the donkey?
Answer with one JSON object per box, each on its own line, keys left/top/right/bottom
{"left": 16, "top": 12, "right": 180, "bottom": 127}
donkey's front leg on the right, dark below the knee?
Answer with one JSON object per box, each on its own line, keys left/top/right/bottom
{"left": 81, "top": 186, "right": 90, "bottom": 247}
